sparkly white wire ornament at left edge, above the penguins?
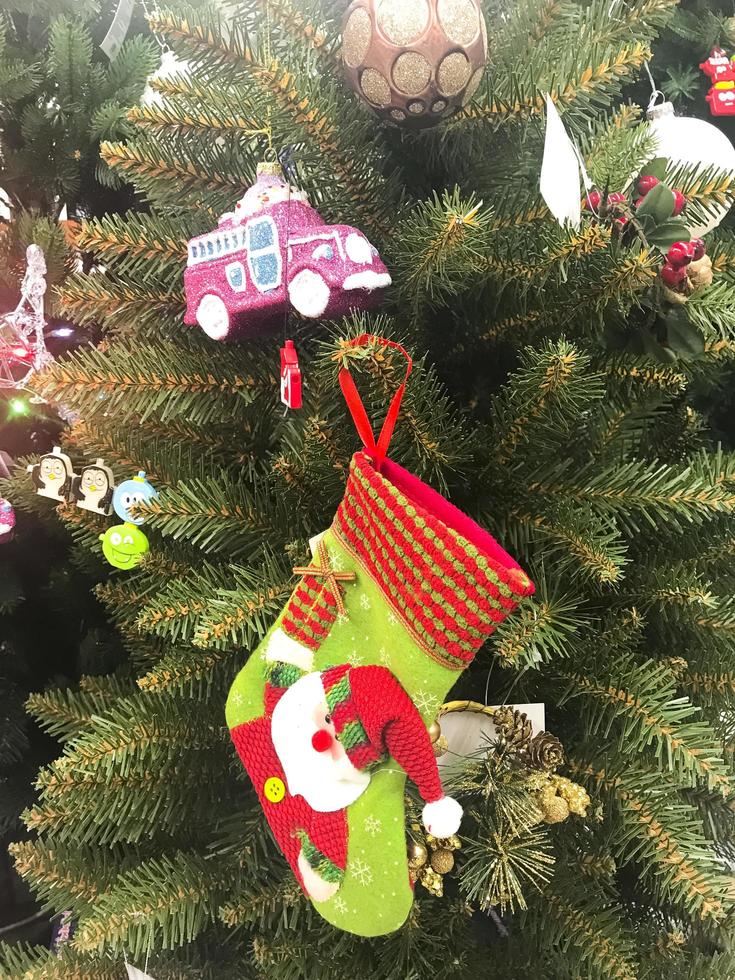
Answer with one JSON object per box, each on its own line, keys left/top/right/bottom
{"left": 0, "top": 245, "right": 53, "bottom": 389}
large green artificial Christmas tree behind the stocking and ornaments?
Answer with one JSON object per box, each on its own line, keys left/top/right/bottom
{"left": 0, "top": 0, "right": 735, "bottom": 980}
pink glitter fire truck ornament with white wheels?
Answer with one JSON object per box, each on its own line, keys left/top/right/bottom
{"left": 184, "top": 163, "right": 391, "bottom": 340}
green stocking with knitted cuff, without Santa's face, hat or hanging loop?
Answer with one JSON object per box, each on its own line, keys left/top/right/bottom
{"left": 227, "top": 453, "right": 533, "bottom": 936}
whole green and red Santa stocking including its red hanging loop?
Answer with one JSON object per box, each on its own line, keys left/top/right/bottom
{"left": 227, "top": 336, "right": 533, "bottom": 936}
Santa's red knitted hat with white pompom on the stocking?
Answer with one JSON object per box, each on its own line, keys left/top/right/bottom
{"left": 320, "top": 664, "right": 462, "bottom": 837}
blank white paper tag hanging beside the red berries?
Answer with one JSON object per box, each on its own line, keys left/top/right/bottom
{"left": 539, "top": 94, "right": 586, "bottom": 230}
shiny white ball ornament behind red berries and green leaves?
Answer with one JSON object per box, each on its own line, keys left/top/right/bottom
{"left": 647, "top": 102, "right": 735, "bottom": 238}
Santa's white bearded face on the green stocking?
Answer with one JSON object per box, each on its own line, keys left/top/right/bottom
{"left": 271, "top": 673, "right": 370, "bottom": 813}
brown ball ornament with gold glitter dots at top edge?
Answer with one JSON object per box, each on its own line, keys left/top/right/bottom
{"left": 342, "top": 0, "right": 487, "bottom": 129}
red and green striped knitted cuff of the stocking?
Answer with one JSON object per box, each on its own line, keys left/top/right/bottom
{"left": 332, "top": 452, "right": 534, "bottom": 668}
